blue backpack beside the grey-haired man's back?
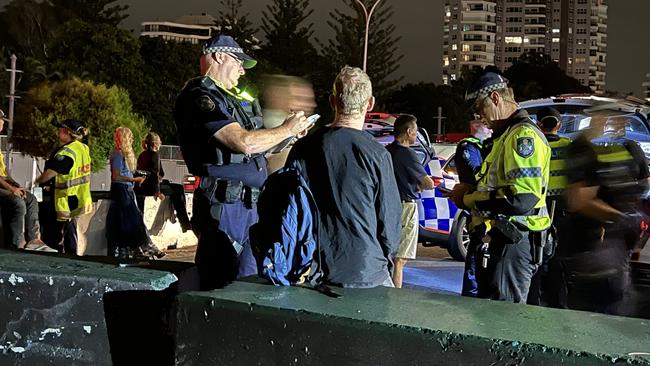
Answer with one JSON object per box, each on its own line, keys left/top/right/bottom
{"left": 251, "top": 164, "right": 320, "bottom": 286}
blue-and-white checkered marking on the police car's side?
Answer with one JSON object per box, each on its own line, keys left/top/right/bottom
{"left": 417, "top": 157, "right": 458, "bottom": 233}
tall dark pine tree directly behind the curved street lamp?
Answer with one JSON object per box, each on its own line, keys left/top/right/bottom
{"left": 323, "top": 0, "right": 403, "bottom": 103}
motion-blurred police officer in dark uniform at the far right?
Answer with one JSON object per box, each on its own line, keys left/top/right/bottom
{"left": 561, "top": 117, "right": 649, "bottom": 313}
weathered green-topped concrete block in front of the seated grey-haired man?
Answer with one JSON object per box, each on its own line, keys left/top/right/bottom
{"left": 176, "top": 282, "right": 650, "bottom": 366}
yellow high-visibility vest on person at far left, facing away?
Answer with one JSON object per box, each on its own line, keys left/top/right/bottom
{"left": 54, "top": 141, "right": 93, "bottom": 221}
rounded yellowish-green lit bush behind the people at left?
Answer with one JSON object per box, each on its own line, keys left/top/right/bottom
{"left": 12, "top": 78, "right": 147, "bottom": 171}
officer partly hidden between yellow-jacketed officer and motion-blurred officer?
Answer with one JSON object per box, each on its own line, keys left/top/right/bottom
{"left": 527, "top": 107, "right": 571, "bottom": 307}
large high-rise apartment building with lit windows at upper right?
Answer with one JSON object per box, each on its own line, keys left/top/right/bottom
{"left": 442, "top": 0, "right": 607, "bottom": 94}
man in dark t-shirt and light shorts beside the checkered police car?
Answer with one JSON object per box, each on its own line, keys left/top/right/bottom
{"left": 386, "top": 114, "right": 434, "bottom": 288}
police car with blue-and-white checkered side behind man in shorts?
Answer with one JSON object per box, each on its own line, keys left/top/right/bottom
{"left": 364, "top": 113, "right": 469, "bottom": 261}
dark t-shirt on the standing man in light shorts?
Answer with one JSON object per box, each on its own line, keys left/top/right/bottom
{"left": 386, "top": 142, "right": 427, "bottom": 201}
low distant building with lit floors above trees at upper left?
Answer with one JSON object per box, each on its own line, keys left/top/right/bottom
{"left": 140, "top": 13, "right": 216, "bottom": 44}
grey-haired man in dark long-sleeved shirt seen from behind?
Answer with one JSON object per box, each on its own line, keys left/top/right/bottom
{"left": 288, "top": 66, "right": 402, "bottom": 287}
